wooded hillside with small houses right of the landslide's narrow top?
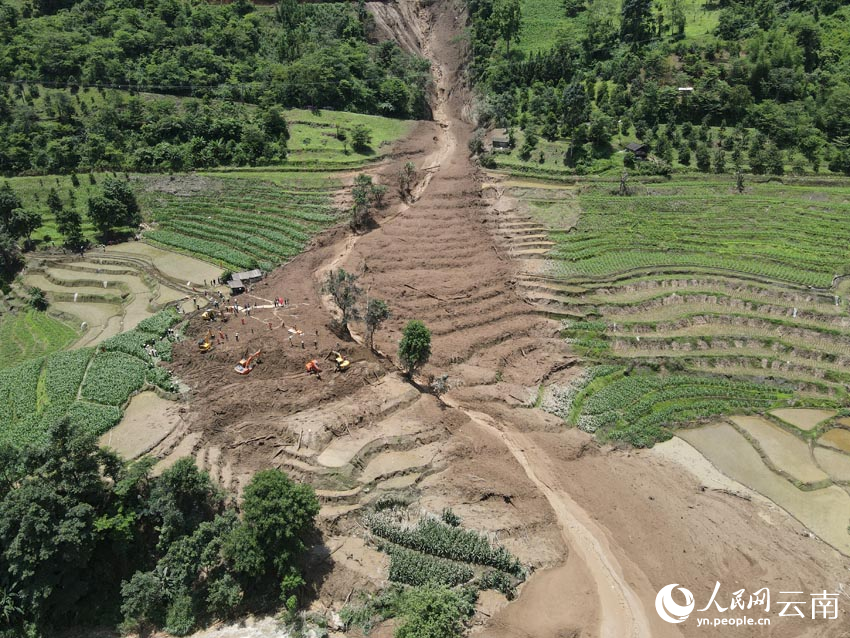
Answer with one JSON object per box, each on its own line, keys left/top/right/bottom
{"left": 470, "top": 0, "right": 850, "bottom": 174}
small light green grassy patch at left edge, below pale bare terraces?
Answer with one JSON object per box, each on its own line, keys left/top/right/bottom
{"left": 0, "top": 310, "right": 79, "bottom": 369}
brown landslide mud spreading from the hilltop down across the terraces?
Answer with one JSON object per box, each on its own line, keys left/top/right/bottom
{"left": 166, "top": 0, "right": 850, "bottom": 638}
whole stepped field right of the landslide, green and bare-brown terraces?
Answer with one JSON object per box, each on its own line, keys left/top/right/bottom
{"left": 496, "top": 180, "right": 850, "bottom": 445}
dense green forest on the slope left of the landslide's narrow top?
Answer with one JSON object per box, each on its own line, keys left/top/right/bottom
{"left": 0, "top": 0, "right": 428, "bottom": 174}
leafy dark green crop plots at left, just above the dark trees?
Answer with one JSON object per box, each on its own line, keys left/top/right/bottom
{"left": 0, "top": 311, "right": 178, "bottom": 445}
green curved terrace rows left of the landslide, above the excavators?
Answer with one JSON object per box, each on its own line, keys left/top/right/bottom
{"left": 137, "top": 172, "right": 339, "bottom": 271}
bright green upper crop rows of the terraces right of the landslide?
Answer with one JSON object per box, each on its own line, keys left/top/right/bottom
{"left": 553, "top": 182, "right": 850, "bottom": 288}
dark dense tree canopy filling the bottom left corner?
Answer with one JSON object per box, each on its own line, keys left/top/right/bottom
{"left": 0, "top": 422, "right": 319, "bottom": 638}
